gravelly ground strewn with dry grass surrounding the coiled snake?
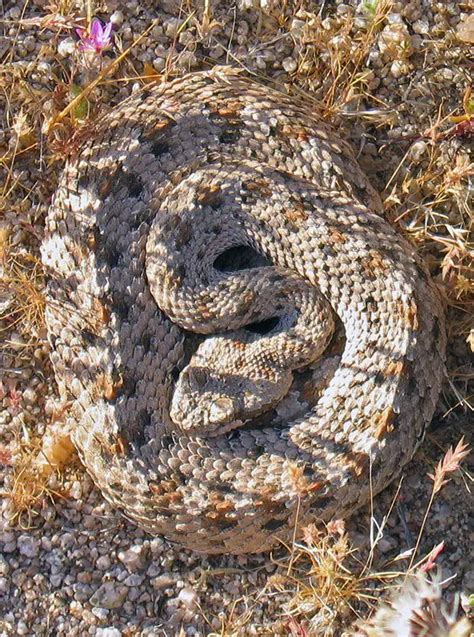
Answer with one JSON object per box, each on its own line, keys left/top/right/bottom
{"left": 0, "top": 0, "right": 474, "bottom": 637}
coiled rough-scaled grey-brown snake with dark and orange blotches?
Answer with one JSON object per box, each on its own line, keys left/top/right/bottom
{"left": 42, "top": 67, "right": 445, "bottom": 553}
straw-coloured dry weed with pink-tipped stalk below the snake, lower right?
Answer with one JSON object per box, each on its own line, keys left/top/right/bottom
{"left": 256, "top": 439, "right": 469, "bottom": 637}
